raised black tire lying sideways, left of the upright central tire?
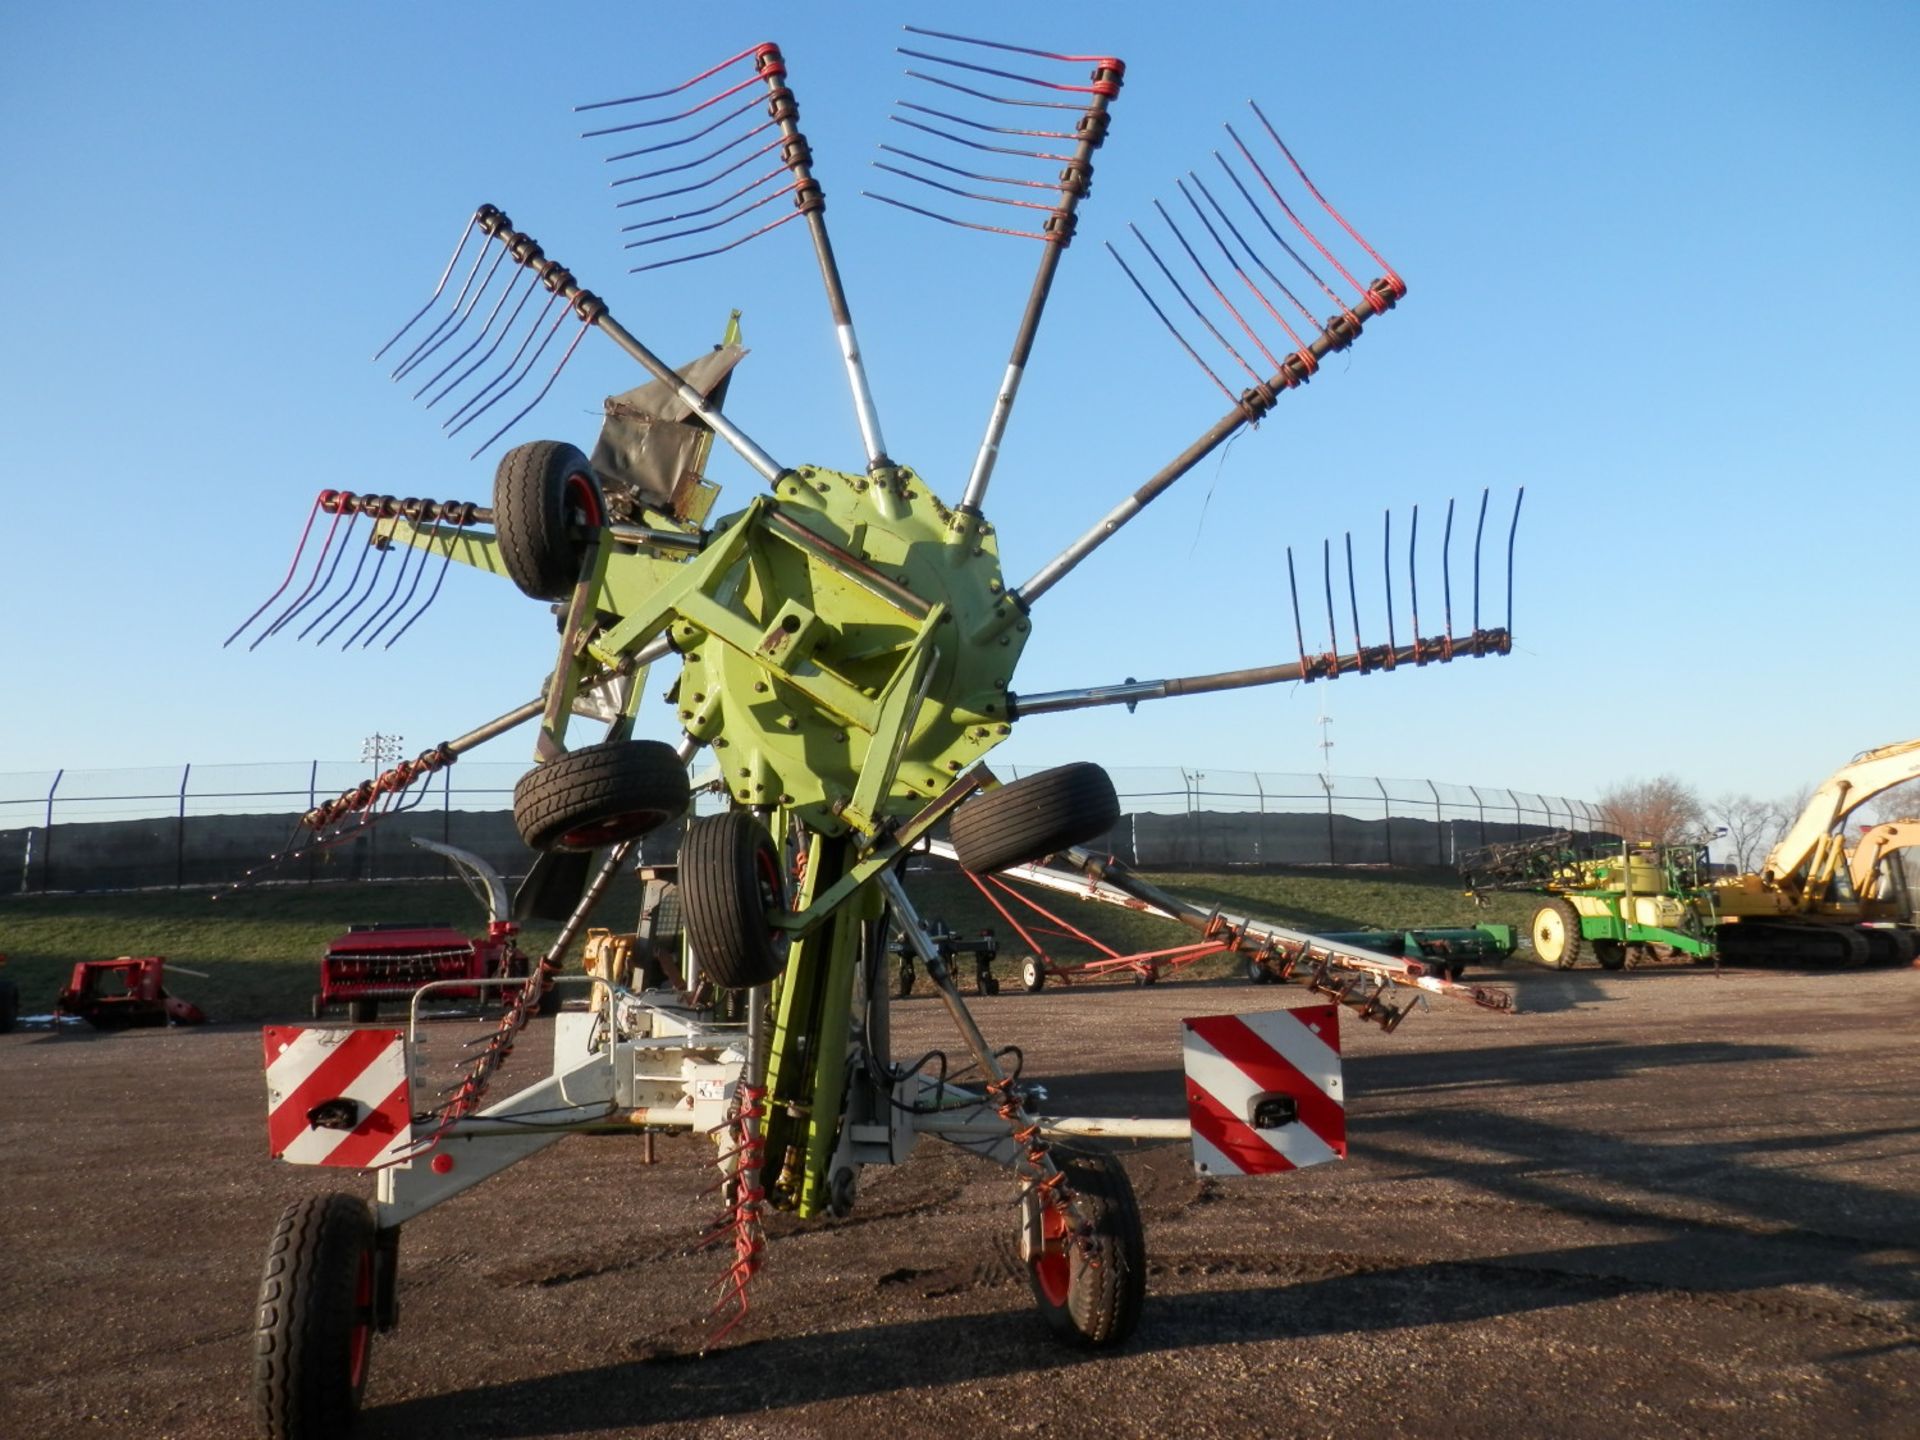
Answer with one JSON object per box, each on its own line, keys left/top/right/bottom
{"left": 513, "top": 739, "right": 693, "bottom": 851}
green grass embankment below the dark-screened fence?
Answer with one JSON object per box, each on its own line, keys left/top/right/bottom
{"left": 0, "top": 870, "right": 1532, "bottom": 1021}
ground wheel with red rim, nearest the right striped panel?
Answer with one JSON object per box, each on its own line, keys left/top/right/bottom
{"left": 1027, "top": 1146, "right": 1146, "bottom": 1350}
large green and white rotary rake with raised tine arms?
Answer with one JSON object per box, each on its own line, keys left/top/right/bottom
{"left": 228, "top": 31, "right": 1511, "bottom": 1434}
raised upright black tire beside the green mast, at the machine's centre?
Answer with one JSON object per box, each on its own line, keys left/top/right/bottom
{"left": 680, "top": 810, "right": 787, "bottom": 991}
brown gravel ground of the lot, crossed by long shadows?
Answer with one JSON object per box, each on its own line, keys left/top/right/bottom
{"left": 0, "top": 968, "right": 1920, "bottom": 1440}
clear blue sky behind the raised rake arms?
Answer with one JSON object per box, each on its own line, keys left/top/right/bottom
{"left": 0, "top": 0, "right": 1920, "bottom": 795}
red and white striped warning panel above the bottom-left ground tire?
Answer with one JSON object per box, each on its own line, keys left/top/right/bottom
{"left": 261, "top": 1025, "right": 413, "bottom": 1169}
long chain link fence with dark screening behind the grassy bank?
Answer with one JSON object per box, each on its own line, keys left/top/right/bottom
{"left": 0, "top": 760, "right": 1601, "bottom": 895}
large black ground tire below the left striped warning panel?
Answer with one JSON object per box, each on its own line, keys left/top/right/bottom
{"left": 253, "top": 1192, "right": 374, "bottom": 1440}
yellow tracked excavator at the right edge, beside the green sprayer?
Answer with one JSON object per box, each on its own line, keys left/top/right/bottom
{"left": 1715, "top": 739, "right": 1920, "bottom": 966}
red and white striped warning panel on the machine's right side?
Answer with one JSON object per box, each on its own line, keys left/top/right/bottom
{"left": 1181, "top": 1004, "right": 1346, "bottom": 1175}
